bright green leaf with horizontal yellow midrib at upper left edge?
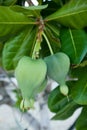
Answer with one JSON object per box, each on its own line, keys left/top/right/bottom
{"left": 0, "top": 6, "right": 34, "bottom": 37}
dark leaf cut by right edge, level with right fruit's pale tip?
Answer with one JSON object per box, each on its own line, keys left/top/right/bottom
{"left": 70, "top": 66, "right": 87, "bottom": 105}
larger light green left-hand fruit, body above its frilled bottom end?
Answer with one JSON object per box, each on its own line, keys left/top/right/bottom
{"left": 15, "top": 56, "right": 47, "bottom": 107}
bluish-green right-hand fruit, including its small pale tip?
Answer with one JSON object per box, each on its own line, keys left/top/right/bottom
{"left": 45, "top": 52, "right": 70, "bottom": 95}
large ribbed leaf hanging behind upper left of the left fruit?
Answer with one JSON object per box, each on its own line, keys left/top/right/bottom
{"left": 2, "top": 26, "right": 36, "bottom": 70}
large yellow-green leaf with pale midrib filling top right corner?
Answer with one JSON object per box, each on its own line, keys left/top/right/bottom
{"left": 46, "top": 0, "right": 87, "bottom": 28}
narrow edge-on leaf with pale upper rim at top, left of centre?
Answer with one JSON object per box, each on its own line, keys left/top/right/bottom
{"left": 10, "top": 5, "right": 48, "bottom": 17}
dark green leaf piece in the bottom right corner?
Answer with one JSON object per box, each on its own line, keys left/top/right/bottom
{"left": 76, "top": 106, "right": 87, "bottom": 130}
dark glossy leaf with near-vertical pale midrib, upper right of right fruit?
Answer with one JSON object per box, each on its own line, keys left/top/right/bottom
{"left": 60, "top": 29, "right": 87, "bottom": 64}
